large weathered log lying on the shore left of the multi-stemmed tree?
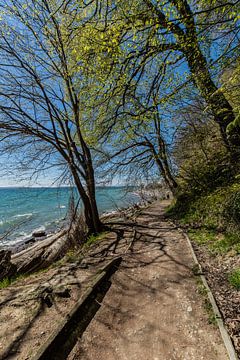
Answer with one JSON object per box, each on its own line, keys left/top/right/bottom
{"left": 11, "top": 230, "right": 71, "bottom": 274}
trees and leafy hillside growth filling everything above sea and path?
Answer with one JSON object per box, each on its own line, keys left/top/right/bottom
{"left": 0, "top": 0, "right": 240, "bottom": 240}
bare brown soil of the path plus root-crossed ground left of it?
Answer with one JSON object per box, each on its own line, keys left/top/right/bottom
{"left": 0, "top": 201, "right": 232, "bottom": 360}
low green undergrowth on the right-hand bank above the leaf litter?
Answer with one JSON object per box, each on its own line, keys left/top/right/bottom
{"left": 167, "top": 181, "right": 240, "bottom": 256}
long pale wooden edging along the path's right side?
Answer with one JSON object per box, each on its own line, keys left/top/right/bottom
{"left": 178, "top": 227, "right": 239, "bottom": 360}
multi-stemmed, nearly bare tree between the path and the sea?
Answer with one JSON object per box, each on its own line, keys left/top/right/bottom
{"left": 0, "top": 0, "right": 102, "bottom": 233}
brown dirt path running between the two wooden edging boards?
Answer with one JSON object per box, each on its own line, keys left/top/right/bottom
{"left": 68, "top": 204, "right": 228, "bottom": 360}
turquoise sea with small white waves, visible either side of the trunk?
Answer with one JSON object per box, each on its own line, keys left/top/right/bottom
{"left": 0, "top": 187, "right": 139, "bottom": 245}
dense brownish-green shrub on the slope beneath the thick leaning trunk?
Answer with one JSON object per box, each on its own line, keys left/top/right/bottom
{"left": 173, "top": 99, "right": 231, "bottom": 195}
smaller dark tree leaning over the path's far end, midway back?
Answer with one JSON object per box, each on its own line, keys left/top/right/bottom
{"left": 99, "top": 94, "right": 178, "bottom": 194}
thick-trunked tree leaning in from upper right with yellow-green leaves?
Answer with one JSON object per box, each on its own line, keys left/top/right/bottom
{"left": 94, "top": 0, "right": 240, "bottom": 157}
